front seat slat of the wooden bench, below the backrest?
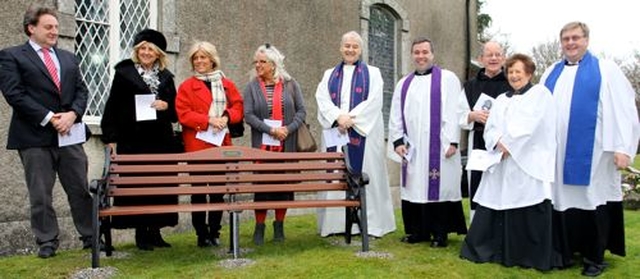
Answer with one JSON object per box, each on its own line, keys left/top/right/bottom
{"left": 100, "top": 200, "right": 360, "bottom": 217}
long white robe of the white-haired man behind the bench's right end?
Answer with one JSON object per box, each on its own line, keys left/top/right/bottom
{"left": 316, "top": 65, "right": 396, "bottom": 237}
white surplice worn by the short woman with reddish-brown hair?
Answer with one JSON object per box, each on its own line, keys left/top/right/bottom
{"left": 473, "top": 85, "right": 556, "bottom": 210}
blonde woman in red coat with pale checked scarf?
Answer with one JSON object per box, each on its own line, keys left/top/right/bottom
{"left": 176, "top": 42, "right": 243, "bottom": 247}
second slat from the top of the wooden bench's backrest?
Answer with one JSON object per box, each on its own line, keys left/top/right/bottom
{"left": 109, "top": 161, "right": 346, "bottom": 174}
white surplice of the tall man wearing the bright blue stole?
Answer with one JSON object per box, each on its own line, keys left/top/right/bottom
{"left": 540, "top": 59, "right": 640, "bottom": 211}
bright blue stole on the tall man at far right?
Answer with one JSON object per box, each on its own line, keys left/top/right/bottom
{"left": 544, "top": 51, "right": 601, "bottom": 186}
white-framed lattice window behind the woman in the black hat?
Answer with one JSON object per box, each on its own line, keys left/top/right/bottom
{"left": 75, "top": 0, "right": 157, "bottom": 123}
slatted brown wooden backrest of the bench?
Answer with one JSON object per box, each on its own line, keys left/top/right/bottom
{"left": 106, "top": 146, "right": 356, "bottom": 196}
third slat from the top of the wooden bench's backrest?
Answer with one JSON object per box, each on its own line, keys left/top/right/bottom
{"left": 109, "top": 172, "right": 346, "bottom": 186}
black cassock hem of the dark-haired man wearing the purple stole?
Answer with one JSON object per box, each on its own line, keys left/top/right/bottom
{"left": 402, "top": 200, "right": 467, "bottom": 241}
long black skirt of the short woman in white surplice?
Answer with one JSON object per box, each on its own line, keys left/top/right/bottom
{"left": 460, "top": 200, "right": 561, "bottom": 271}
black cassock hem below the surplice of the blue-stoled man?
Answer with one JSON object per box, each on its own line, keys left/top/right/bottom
{"left": 553, "top": 202, "right": 626, "bottom": 266}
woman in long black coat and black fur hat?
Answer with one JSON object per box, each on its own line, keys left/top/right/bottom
{"left": 101, "top": 29, "right": 183, "bottom": 250}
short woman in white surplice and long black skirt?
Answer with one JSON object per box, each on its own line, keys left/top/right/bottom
{"left": 460, "top": 54, "right": 562, "bottom": 271}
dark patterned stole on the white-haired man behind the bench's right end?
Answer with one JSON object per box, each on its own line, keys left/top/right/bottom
{"left": 327, "top": 60, "right": 369, "bottom": 173}
